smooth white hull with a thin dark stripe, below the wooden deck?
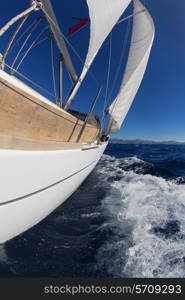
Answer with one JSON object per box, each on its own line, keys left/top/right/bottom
{"left": 0, "top": 144, "right": 107, "bottom": 243}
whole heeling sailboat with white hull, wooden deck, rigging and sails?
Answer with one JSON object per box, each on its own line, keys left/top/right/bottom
{"left": 0, "top": 0, "right": 155, "bottom": 243}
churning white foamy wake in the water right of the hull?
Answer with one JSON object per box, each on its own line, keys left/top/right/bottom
{"left": 96, "top": 155, "right": 185, "bottom": 277}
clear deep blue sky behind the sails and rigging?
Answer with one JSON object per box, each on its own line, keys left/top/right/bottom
{"left": 0, "top": 0, "right": 185, "bottom": 141}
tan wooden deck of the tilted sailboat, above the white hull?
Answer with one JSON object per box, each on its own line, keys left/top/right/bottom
{"left": 0, "top": 71, "right": 99, "bottom": 150}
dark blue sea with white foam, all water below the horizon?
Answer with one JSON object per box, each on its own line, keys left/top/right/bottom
{"left": 0, "top": 144, "right": 185, "bottom": 278}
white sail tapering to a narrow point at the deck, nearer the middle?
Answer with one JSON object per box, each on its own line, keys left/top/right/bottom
{"left": 66, "top": 0, "right": 131, "bottom": 108}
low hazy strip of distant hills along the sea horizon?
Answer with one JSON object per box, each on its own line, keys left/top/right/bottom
{"left": 110, "top": 139, "right": 185, "bottom": 145}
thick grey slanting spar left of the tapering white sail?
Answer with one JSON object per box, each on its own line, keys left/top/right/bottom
{"left": 40, "top": 0, "right": 78, "bottom": 82}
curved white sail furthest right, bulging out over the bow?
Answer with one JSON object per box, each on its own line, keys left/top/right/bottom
{"left": 107, "top": 0, "right": 155, "bottom": 133}
